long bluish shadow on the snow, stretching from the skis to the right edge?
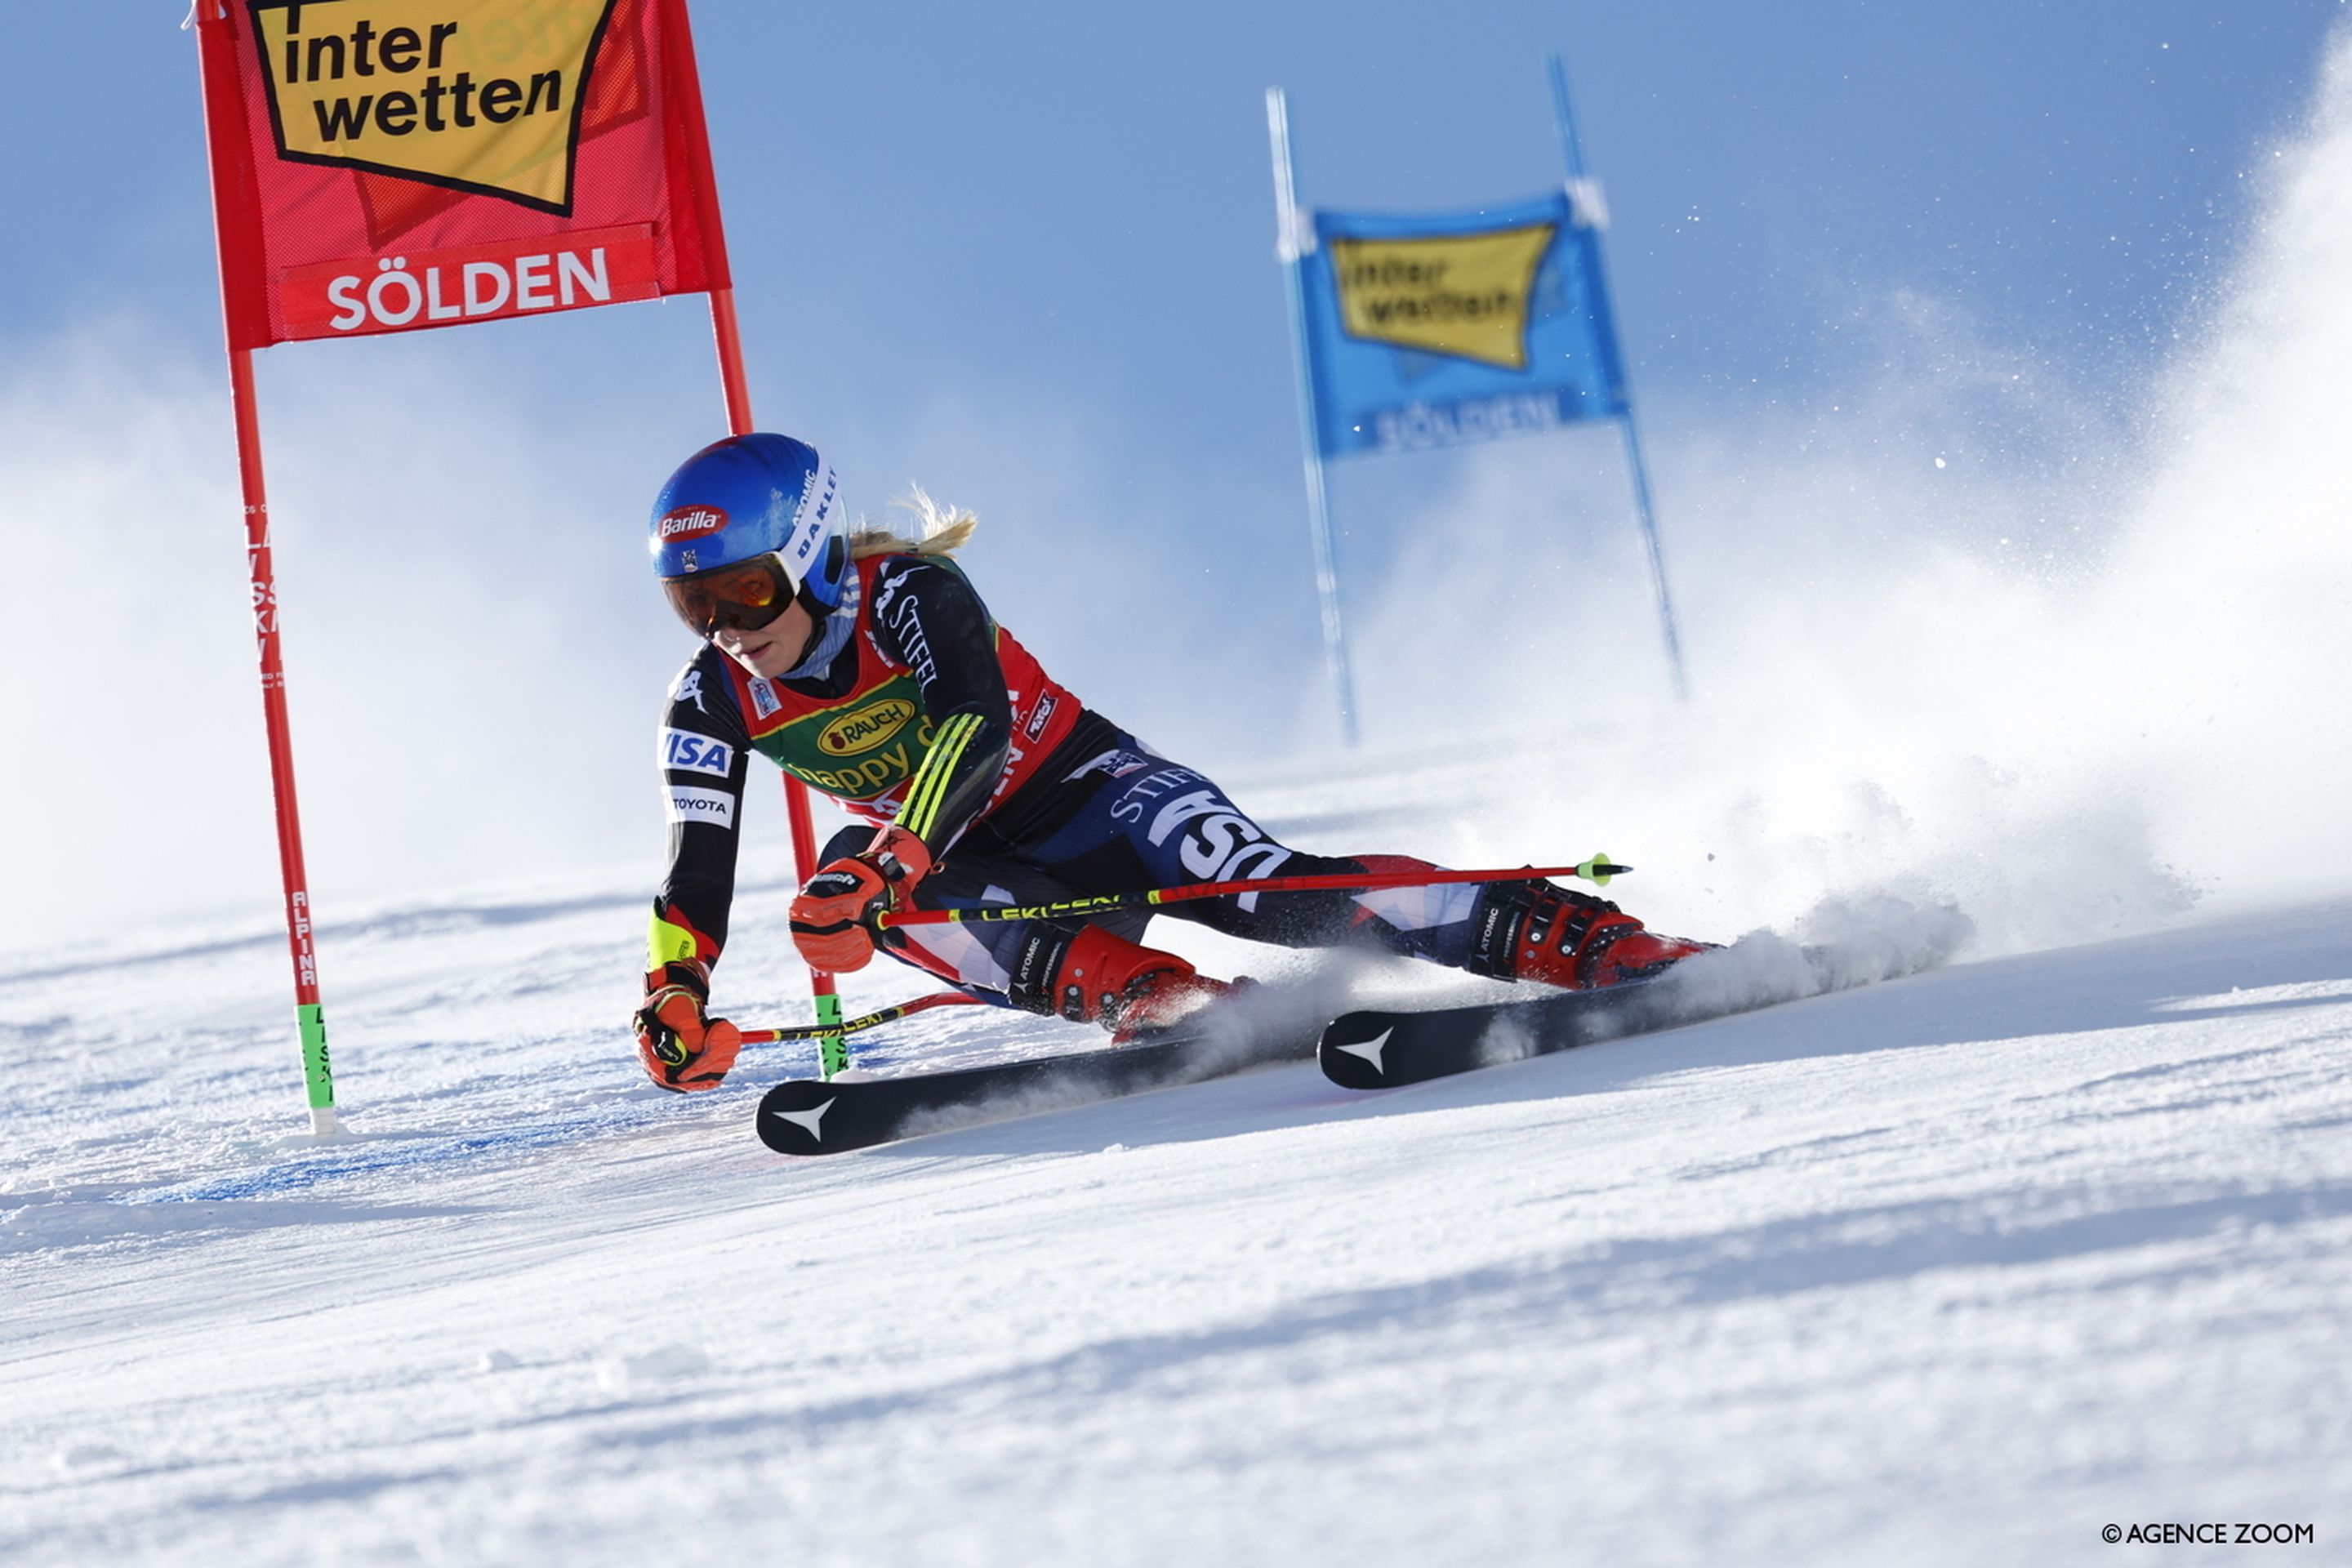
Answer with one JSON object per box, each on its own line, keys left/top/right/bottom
{"left": 868, "top": 902, "right": 2352, "bottom": 1159}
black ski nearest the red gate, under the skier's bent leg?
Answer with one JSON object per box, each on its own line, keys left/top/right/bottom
{"left": 760, "top": 1027, "right": 1315, "bottom": 1154}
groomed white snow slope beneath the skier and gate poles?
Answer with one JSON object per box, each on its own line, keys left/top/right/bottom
{"left": 0, "top": 865, "right": 2352, "bottom": 1563}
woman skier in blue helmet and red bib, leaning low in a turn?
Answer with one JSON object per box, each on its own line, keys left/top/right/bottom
{"left": 635, "top": 435, "right": 1700, "bottom": 1091}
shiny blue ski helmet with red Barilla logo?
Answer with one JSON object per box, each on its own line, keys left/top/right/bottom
{"left": 647, "top": 433, "right": 849, "bottom": 609}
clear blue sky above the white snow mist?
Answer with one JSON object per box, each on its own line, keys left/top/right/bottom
{"left": 0, "top": 0, "right": 2342, "bottom": 404}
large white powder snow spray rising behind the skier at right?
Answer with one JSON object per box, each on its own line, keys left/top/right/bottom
{"left": 1326, "top": 27, "right": 2352, "bottom": 950}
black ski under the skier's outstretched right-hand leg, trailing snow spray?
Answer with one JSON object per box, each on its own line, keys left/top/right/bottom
{"left": 1315, "top": 950, "right": 1858, "bottom": 1089}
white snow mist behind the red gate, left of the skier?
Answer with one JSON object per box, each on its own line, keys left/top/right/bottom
{"left": 0, "top": 324, "right": 715, "bottom": 945}
